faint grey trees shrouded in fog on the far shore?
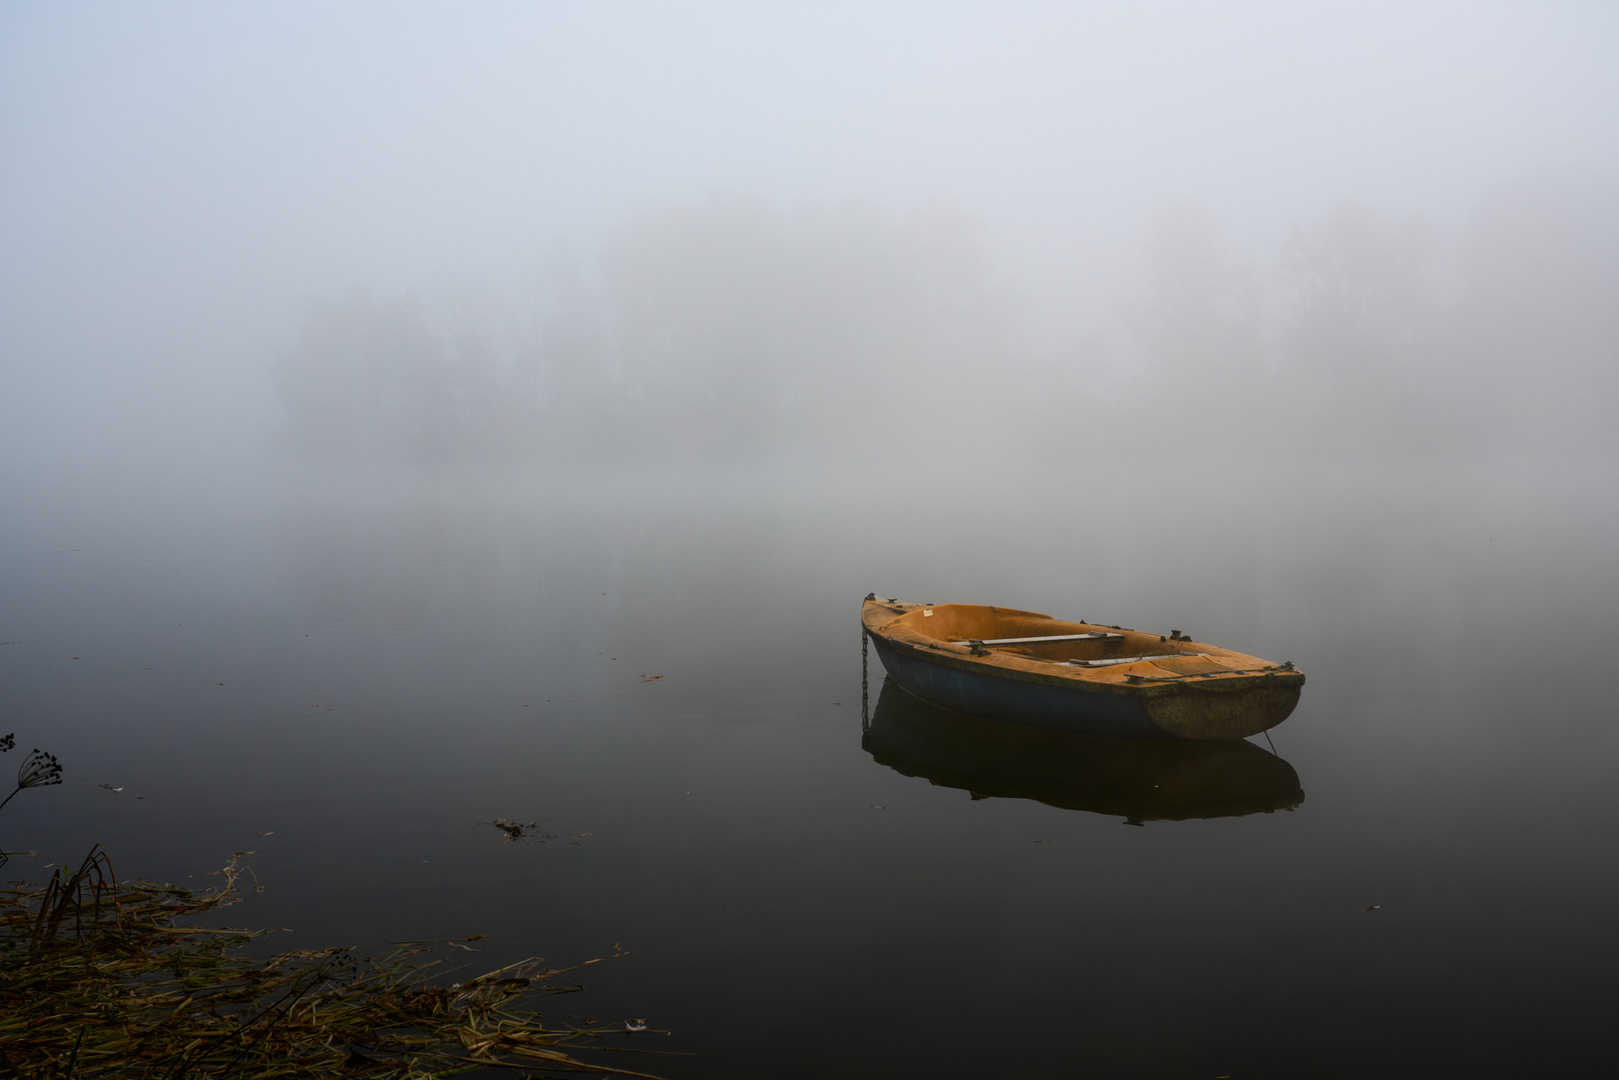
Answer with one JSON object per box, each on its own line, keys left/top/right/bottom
{"left": 275, "top": 181, "right": 1619, "bottom": 466}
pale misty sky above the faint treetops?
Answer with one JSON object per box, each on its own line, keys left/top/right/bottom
{"left": 0, "top": 2, "right": 1619, "bottom": 460}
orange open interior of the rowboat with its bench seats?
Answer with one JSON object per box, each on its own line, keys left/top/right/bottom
{"left": 889, "top": 604, "right": 1224, "bottom": 662}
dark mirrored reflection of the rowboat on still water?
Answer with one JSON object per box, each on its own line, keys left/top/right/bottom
{"left": 861, "top": 678, "right": 1305, "bottom": 823}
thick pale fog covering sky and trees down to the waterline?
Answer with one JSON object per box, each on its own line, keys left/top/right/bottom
{"left": 0, "top": 3, "right": 1619, "bottom": 478}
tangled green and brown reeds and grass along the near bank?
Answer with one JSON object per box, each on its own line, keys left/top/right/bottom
{"left": 0, "top": 847, "right": 649, "bottom": 1080}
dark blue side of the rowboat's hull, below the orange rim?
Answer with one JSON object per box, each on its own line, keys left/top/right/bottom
{"left": 869, "top": 635, "right": 1174, "bottom": 738}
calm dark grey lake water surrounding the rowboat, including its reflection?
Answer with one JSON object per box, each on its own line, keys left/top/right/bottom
{"left": 0, "top": 468, "right": 1619, "bottom": 1078}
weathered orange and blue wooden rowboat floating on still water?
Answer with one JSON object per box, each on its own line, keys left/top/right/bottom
{"left": 860, "top": 596, "right": 1305, "bottom": 738}
